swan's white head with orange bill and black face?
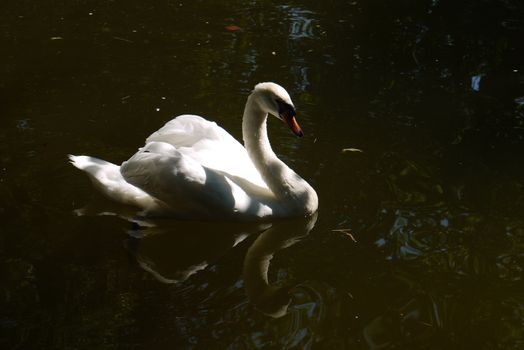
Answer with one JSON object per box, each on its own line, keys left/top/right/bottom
{"left": 252, "top": 83, "right": 304, "bottom": 137}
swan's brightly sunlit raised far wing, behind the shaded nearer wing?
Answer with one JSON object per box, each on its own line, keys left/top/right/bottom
{"left": 146, "top": 115, "right": 267, "bottom": 188}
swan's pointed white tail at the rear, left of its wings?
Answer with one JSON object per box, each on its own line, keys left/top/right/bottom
{"left": 69, "top": 154, "right": 161, "bottom": 211}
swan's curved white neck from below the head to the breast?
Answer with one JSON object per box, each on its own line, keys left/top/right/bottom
{"left": 242, "top": 94, "right": 318, "bottom": 215}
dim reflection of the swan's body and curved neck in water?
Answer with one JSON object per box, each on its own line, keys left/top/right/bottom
{"left": 125, "top": 214, "right": 317, "bottom": 317}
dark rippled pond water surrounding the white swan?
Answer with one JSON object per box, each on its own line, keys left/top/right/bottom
{"left": 0, "top": 0, "right": 524, "bottom": 349}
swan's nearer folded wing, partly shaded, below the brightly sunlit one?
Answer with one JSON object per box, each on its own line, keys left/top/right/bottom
{"left": 120, "top": 142, "right": 235, "bottom": 217}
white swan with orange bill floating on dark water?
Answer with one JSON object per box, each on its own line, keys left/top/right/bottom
{"left": 69, "top": 83, "right": 318, "bottom": 220}
